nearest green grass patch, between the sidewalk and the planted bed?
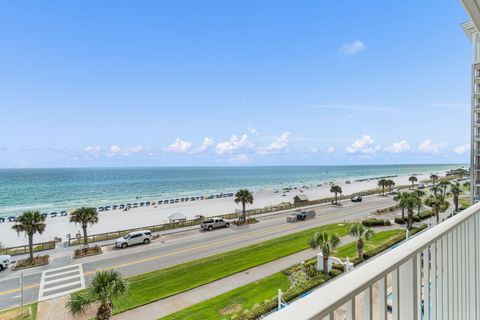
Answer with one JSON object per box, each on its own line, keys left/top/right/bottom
{"left": 162, "top": 272, "right": 290, "bottom": 320}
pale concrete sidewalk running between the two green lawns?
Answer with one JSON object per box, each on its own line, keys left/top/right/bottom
{"left": 112, "top": 236, "right": 355, "bottom": 320}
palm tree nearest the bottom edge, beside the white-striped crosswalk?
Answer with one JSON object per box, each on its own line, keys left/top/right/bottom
{"left": 66, "top": 270, "right": 128, "bottom": 320}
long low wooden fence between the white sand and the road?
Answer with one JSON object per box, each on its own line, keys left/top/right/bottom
{"left": 68, "top": 185, "right": 410, "bottom": 246}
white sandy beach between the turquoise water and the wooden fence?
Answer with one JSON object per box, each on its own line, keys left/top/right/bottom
{"left": 0, "top": 173, "right": 438, "bottom": 247}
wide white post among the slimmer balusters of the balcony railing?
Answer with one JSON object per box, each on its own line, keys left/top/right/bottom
{"left": 398, "top": 256, "right": 419, "bottom": 320}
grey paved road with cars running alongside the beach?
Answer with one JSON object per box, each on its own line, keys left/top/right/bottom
{"left": 0, "top": 196, "right": 394, "bottom": 310}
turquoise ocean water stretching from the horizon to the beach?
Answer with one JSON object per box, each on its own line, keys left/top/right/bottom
{"left": 0, "top": 164, "right": 461, "bottom": 215}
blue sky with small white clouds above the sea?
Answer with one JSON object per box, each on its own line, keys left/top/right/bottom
{"left": 0, "top": 0, "right": 471, "bottom": 167}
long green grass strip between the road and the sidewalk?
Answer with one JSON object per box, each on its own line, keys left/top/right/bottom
{"left": 114, "top": 224, "right": 350, "bottom": 313}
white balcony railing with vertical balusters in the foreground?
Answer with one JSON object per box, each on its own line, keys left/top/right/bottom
{"left": 267, "top": 204, "right": 480, "bottom": 320}
